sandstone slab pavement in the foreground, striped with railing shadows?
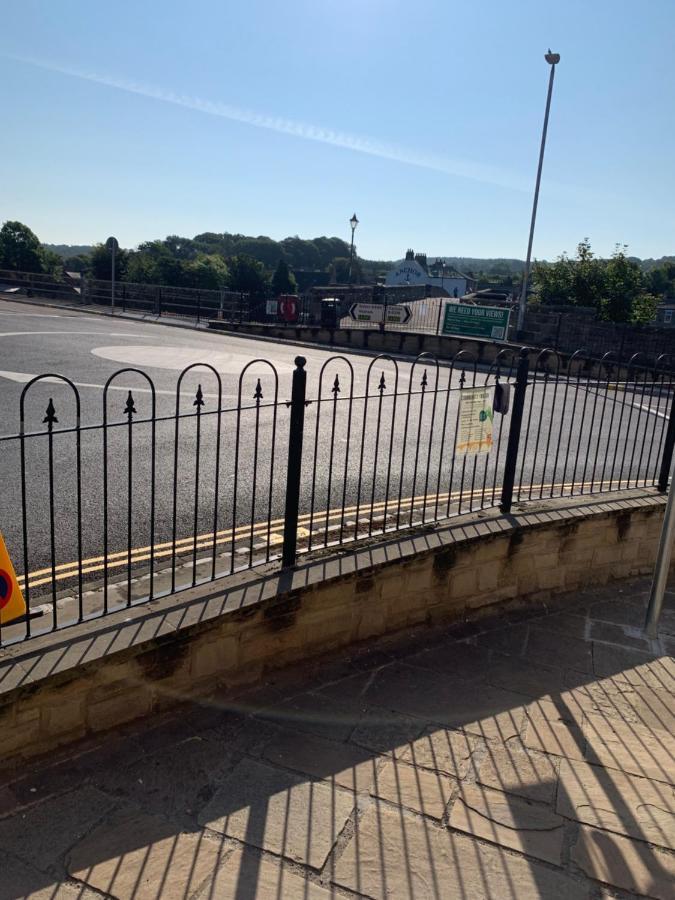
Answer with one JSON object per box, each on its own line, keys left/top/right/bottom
{"left": 0, "top": 580, "right": 675, "bottom": 900}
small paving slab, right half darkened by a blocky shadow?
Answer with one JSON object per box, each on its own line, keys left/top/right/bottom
{"left": 449, "top": 784, "right": 565, "bottom": 866}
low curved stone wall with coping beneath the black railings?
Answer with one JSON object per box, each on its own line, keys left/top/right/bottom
{"left": 0, "top": 491, "right": 665, "bottom": 768}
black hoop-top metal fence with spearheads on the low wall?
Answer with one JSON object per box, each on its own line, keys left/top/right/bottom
{"left": 0, "top": 350, "right": 675, "bottom": 643}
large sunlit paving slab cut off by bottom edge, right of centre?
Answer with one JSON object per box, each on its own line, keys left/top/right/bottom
{"left": 334, "top": 804, "right": 589, "bottom": 900}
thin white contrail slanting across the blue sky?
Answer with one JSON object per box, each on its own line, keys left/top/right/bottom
{"left": 6, "top": 54, "right": 532, "bottom": 192}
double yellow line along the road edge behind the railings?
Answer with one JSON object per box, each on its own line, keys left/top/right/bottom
{"left": 17, "top": 480, "right": 629, "bottom": 588}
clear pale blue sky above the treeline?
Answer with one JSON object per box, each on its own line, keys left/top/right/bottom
{"left": 0, "top": 0, "right": 675, "bottom": 259}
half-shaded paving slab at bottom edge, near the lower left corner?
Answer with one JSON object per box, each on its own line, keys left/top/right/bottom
{"left": 68, "top": 810, "right": 229, "bottom": 900}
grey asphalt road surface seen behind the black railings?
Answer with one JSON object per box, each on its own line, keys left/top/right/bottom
{"left": 0, "top": 299, "right": 668, "bottom": 604}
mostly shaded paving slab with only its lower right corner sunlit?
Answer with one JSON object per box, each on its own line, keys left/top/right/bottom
{"left": 263, "top": 731, "right": 379, "bottom": 793}
